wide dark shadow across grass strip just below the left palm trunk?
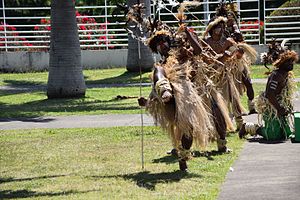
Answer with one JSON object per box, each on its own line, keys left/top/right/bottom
{"left": 0, "top": 98, "right": 140, "bottom": 119}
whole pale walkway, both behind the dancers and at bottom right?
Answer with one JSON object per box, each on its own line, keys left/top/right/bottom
{"left": 0, "top": 85, "right": 300, "bottom": 200}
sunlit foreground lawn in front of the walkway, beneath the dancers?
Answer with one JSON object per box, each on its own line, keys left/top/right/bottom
{"left": 0, "top": 127, "right": 243, "bottom": 200}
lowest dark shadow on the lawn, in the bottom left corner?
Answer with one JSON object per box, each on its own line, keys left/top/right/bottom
{"left": 0, "top": 190, "right": 95, "bottom": 199}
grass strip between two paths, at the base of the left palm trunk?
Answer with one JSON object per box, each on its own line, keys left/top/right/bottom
{"left": 0, "top": 87, "right": 151, "bottom": 118}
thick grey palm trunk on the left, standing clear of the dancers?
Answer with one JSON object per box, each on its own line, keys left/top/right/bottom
{"left": 47, "top": 0, "right": 86, "bottom": 98}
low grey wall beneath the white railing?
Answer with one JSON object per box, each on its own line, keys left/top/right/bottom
{"left": 0, "top": 44, "right": 300, "bottom": 72}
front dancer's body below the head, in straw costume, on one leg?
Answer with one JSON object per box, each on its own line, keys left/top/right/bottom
{"left": 146, "top": 36, "right": 216, "bottom": 170}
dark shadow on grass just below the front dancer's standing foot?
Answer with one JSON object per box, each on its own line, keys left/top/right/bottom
{"left": 93, "top": 170, "right": 203, "bottom": 191}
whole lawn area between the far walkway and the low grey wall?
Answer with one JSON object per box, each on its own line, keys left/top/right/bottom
{"left": 0, "top": 66, "right": 300, "bottom": 118}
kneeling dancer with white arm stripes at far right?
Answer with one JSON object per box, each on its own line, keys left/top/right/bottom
{"left": 239, "top": 50, "right": 298, "bottom": 141}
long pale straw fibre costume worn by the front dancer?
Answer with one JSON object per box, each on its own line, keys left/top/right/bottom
{"left": 147, "top": 52, "right": 214, "bottom": 148}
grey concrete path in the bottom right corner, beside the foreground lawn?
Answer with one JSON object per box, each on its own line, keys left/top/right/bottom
{"left": 218, "top": 142, "right": 300, "bottom": 200}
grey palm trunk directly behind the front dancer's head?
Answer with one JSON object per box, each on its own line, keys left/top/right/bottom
{"left": 126, "top": 0, "right": 154, "bottom": 71}
